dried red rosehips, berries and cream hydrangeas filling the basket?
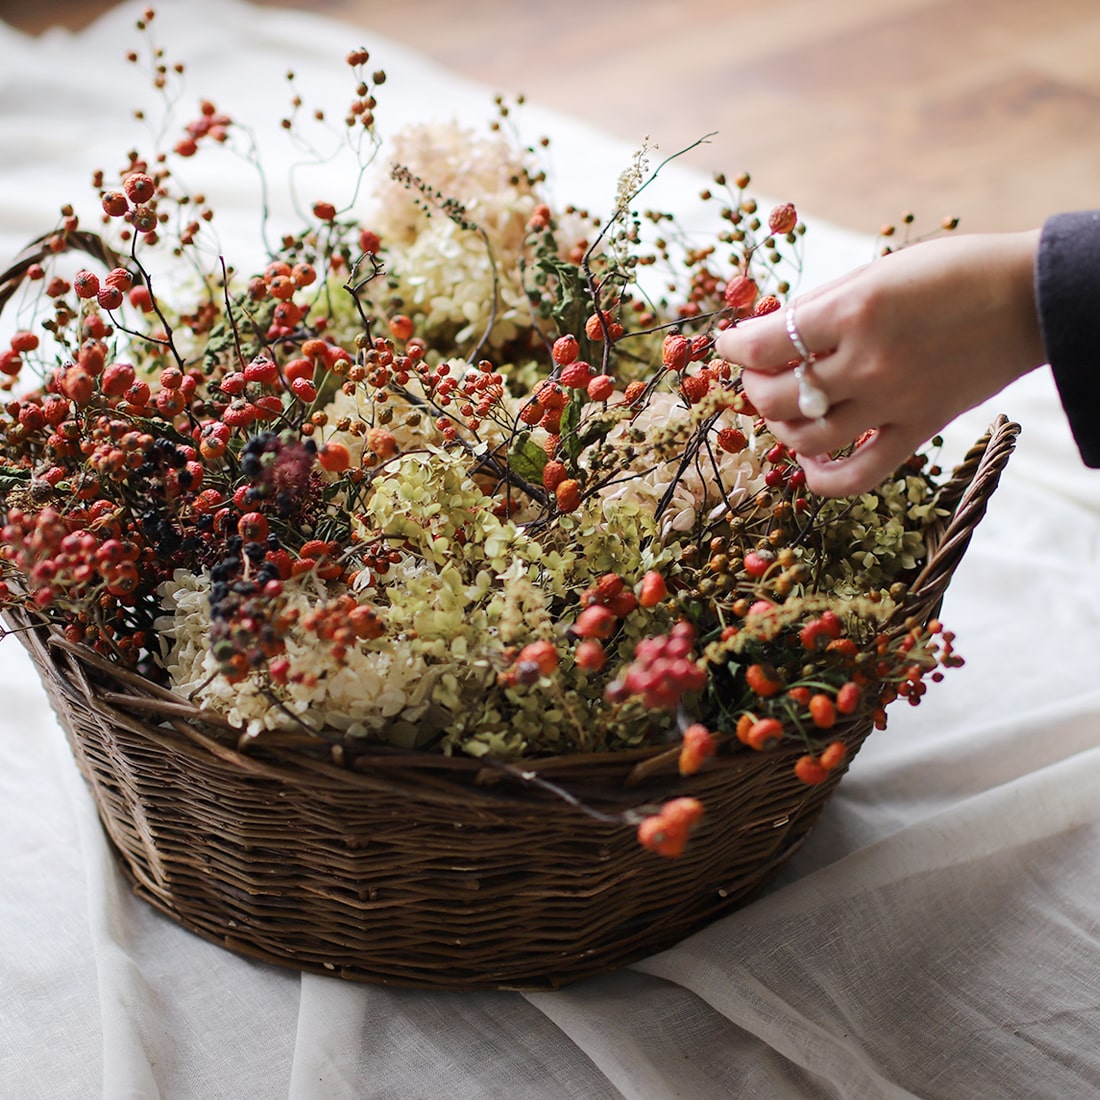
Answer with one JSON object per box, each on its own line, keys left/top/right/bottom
{"left": 0, "top": 12, "right": 960, "bottom": 855}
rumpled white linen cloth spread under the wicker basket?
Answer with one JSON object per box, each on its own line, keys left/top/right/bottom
{"left": 0, "top": 0, "right": 1100, "bottom": 1100}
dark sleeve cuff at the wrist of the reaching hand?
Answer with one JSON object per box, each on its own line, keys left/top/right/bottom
{"left": 1035, "top": 210, "right": 1100, "bottom": 466}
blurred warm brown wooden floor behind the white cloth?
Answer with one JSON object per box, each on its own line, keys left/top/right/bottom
{"left": 0, "top": 0, "right": 1100, "bottom": 231}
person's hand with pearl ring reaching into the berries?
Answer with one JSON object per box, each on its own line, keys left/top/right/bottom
{"left": 715, "top": 230, "right": 1045, "bottom": 496}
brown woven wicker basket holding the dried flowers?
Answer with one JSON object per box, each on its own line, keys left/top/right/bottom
{"left": 11, "top": 417, "right": 1018, "bottom": 989}
